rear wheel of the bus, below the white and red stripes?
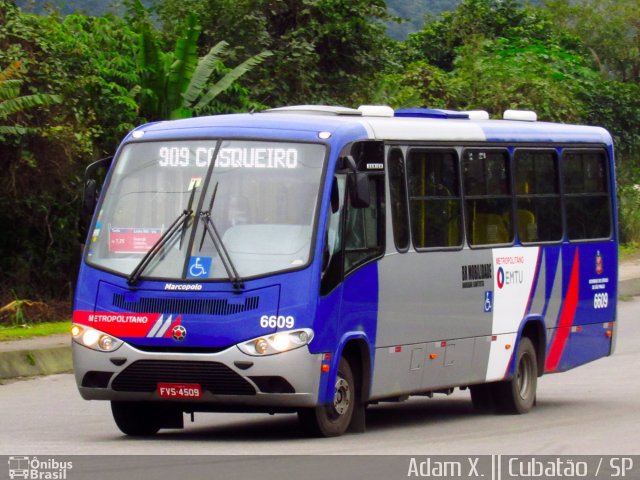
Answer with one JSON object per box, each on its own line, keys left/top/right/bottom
{"left": 494, "top": 337, "right": 538, "bottom": 414}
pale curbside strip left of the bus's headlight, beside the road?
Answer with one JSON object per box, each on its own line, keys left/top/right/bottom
{"left": 0, "top": 346, "right": 73, "bottom": 380}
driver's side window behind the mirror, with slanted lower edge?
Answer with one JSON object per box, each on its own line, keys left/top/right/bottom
{"left": 344, "top": 175, "right": 384, "bottom": 274}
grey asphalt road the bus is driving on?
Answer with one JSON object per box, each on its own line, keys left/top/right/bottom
{"left": 0, "top": 297, "right": 640, "bottom": 455}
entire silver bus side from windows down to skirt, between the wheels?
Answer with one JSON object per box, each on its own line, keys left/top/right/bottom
{"left": 372, "top": 248, "right": 493, "bottom": 399}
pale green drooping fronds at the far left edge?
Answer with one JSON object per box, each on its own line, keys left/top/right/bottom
{"left": 0, "top": 61, "right": 62, "bottom": 139}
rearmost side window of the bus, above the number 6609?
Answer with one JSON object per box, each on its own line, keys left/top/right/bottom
{"left": 562, "top": 150, "right": 611, "bottom": 240}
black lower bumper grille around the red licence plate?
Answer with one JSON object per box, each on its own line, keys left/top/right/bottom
{"left": 112, "top": 360, "right": 256, "bottom": 395}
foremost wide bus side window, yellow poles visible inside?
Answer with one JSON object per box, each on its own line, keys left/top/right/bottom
{"left": 408, "top": 149, "right": 462, "bottom": 250}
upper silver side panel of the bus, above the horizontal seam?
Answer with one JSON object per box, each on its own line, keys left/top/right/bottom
{"left": 376, "top": 249, "right": 493, "bottom": 347}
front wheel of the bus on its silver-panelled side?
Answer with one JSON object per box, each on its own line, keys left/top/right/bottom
{"left": 298, "top": 357, "right": 356, "bottom": 437}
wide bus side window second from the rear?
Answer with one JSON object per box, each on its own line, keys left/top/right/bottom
{"left": 514, "top": 150, "right": 562, "bottom": 244}
